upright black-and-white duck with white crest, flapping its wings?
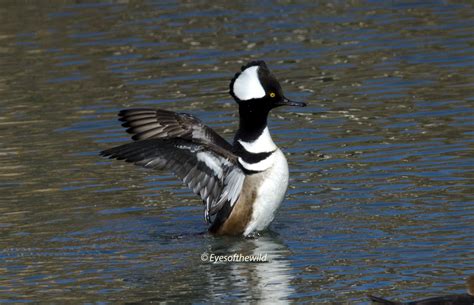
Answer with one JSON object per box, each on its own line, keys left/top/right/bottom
{"left": 101, "top": 61, "right": 306, "bottom": 236}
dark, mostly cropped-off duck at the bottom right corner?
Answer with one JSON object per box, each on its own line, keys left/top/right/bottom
{"left": 368, "top": 275, "right": 474, "bottom": 305}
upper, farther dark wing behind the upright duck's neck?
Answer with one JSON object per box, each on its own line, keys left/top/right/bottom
{"left": 119, "top": 108, "right": 232, "bottom": 150}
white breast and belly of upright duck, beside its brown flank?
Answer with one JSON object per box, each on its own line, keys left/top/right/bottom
{"left": 244, "top": 149, "right": 289, "bottom": 236}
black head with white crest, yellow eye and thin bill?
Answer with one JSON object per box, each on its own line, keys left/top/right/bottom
{"left": 229, "top": 60, "right": 306, "bottom": 113}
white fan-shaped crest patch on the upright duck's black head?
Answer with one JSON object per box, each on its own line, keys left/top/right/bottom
{"left": 233, "top": 66, "right": 265, "bottom": 101}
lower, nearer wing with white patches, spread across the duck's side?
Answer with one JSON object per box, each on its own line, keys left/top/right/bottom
{"left": 101, "top": 138, "right": 245, "bottom": 222}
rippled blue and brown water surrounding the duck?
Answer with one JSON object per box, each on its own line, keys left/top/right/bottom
{"left": 0, "top": 1, "right": 474, "bottom": 304}
